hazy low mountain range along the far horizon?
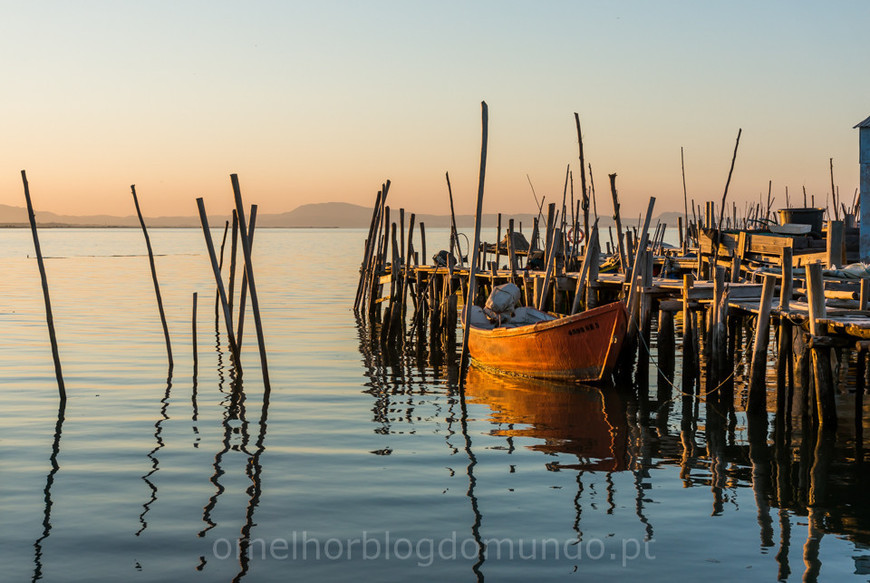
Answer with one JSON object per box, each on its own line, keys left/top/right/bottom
{"left": 0, "top": 202, "right": 679, "bottom": 229}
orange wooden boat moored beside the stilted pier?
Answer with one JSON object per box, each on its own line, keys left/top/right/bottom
{"left": 466, "top": 302, "right": 628, "bottom": 382}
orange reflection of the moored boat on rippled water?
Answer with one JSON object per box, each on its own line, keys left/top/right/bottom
{"left": 465, "top": 366, "right": 629, "bottom": 471}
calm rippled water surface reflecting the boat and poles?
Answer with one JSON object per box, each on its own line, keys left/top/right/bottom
{"left": 0, "top": 229, "right": 870, "bottom": 582}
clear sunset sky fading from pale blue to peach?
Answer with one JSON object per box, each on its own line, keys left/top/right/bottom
{"left": 0, "top": 0, "right": 870, "bottom": 216}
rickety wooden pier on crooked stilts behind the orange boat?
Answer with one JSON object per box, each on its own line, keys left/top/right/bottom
{"left": 356, "top": 194, "right": 870, "bottom": 428}
